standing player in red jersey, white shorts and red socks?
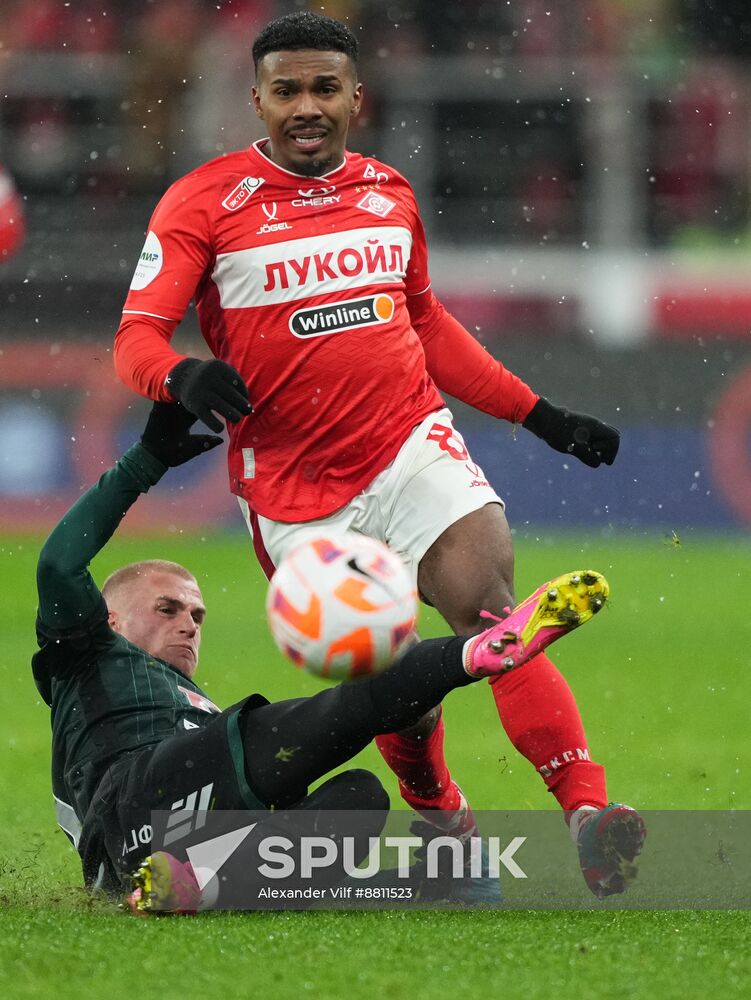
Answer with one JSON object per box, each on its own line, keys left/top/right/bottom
{"left": 115, "top": 12, "right": 643, "bottom": 891}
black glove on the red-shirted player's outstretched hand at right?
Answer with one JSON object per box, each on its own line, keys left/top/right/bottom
{"left": 522, "top": 396, "right": 621, "bottom": 469}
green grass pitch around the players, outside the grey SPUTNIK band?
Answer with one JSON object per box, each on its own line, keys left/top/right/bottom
{"left": 0, "top": 532, "right": 751, "bottom": 1000}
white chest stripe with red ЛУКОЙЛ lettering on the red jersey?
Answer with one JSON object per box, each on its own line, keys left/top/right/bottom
{"left": 211, "top": 226, "right": 412, "bottom": 309}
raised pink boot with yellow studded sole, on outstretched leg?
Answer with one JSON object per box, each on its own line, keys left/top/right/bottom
{"left": 464, "top": 569, "right": 610, "bottom": 677}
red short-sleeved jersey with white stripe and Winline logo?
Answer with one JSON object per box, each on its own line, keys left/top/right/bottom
{"left": 124, "top": 143, "right": 443, "bottom": 521}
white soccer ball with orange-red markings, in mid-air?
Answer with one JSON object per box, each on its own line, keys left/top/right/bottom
{"left": 266, "top": 531, "right": 417, "bottom": 681}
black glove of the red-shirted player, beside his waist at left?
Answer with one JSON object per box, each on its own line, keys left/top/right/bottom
{"left": 165, "top": 358, "right": 253, "bottom": 431}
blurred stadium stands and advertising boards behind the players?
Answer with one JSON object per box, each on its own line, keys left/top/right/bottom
{"left": 0, "top": 0, "right": 751, "bottom": 537}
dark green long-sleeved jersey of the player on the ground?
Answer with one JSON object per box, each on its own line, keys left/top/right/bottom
{"left": 32, "top": 445, "right": 219, "bottom": 839}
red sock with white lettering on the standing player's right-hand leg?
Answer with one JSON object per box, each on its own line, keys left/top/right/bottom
{"left": 490, "top": 653, "right": 608, "bottom": 812}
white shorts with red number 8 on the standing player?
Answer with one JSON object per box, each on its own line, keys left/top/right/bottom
{"left": 238, "top": 408, "right": 503, "bottom": 584}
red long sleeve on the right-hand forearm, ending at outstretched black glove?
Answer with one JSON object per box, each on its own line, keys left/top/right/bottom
{"left": 407, "top": 289, "right": 540, "bottom": 423}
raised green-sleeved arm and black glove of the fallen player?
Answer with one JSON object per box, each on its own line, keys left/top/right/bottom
{"left": 37, "top": 403, "right": 222, "bottom": 630}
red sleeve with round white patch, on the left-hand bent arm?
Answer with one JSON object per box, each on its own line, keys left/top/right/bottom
{"left": 114, "top": 174, "right": 217, "bottom": 400}
